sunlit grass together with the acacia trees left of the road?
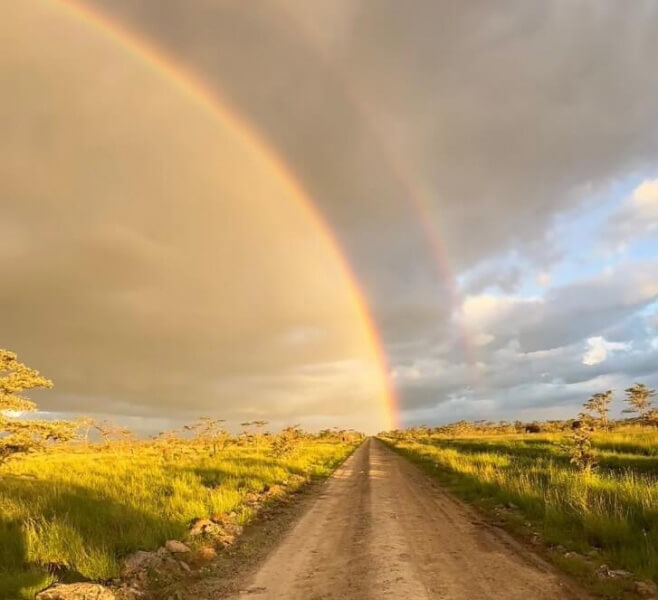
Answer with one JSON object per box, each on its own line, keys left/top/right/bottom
{"left": 0, "top": 351, "right": 362, "bottom": 599}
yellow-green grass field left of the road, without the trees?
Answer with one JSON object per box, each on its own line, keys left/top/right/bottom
{"left": 0, "top": 439, "right": 355, "bottom": 599}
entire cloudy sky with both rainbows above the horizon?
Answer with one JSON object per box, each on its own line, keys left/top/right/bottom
{"left": 0, "top": 0, "right": 658, "bottom": 432}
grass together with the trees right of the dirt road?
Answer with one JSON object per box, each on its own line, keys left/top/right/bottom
{"left": 380, "top": 384, "right": 658, "bottom": 593}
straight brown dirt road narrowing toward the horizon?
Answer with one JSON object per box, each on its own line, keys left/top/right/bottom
{"left": 227, "top": 440, "right": 586, "bottom": 600}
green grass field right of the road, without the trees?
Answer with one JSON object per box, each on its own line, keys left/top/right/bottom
{"left": 376, "top": 428, "right": 658, "bottom": 592}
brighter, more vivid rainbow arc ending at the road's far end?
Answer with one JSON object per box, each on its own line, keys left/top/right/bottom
{"left": 48, "top": 0, "right": 400, "bottom": 428}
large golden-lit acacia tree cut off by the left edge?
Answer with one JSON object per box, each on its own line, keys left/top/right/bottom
{"left": 0, "top": 349, "right": 76, "bottom": 463}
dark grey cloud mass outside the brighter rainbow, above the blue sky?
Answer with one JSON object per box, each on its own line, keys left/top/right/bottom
{"left": 79, "top": 0, "right": 658, "bottom": 270}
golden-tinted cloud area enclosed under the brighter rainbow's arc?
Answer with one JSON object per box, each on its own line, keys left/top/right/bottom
{"left": 0, "top": 3, "right": 386, "bottom": 430}
